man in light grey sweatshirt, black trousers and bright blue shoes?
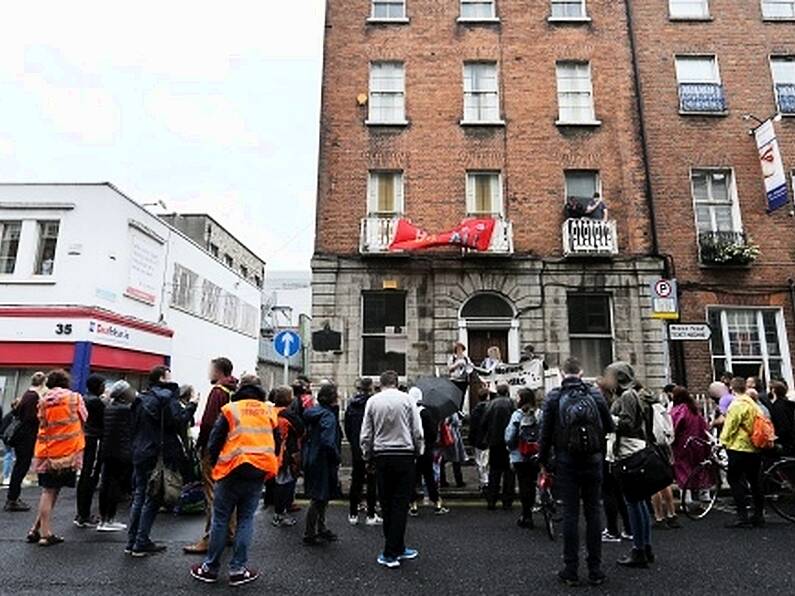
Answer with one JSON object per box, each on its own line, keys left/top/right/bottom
{"left": 360, "top": 371, "right": 424, "bottom": 569}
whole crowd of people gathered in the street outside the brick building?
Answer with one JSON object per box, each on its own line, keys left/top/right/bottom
{"left": 3, "top": 343, "right": 795, "bottom": 585}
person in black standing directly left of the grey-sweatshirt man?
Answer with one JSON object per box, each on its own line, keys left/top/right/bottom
{"left": 345, "top": 377, "right": 383, "bottom": 526}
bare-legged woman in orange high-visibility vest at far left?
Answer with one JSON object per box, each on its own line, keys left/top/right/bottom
{"left": 28, "top": 370, "right": 88, "bottom": 546}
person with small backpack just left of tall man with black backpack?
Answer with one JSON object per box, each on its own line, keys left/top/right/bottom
{"left": 505, "top": 387, "right": 542, "bottom": 528}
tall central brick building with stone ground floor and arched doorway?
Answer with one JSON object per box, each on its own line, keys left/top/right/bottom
{"left": 312, "top": 0, "right": 668, "bottom": 388}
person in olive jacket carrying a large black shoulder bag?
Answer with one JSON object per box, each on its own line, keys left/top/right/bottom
{"left": 605, "top": 362, "right": 655, "bottom": 568}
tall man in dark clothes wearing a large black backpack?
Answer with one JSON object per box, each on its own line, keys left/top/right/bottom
{"left": 539, "top": 358, "right": 613, "bottom": 586}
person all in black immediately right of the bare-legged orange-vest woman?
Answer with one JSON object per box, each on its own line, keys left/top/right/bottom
{"left": 74, "top": 375, "right": 105, "bottom": 528}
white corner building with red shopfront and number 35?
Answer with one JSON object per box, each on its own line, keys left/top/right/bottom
{"left": 0, "top": 183, "right": 261, "bottom": 406}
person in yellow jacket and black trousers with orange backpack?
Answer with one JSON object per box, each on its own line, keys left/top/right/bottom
{"left": 720, "top": 377, "right": 765, "bottom": 528}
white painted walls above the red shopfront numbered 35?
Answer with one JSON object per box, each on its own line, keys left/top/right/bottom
{"left": 0, "top": 184, "right": 261, "bottom": 395}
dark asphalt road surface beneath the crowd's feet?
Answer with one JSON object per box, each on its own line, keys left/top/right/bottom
{"left": 0, "top": 489, "right": 795, "bottom": 596}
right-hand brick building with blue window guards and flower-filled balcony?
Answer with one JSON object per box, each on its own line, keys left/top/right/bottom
{"left": 628, "top": 0, "right": 795, "bottom": 391}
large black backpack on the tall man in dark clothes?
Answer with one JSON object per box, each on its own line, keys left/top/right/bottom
{"left": 559, "top": 384, "right": 605, "bottom": 456}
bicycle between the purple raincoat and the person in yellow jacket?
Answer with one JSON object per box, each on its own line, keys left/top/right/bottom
{"left": 679, "top": 437, "right": 729, "bottom": 520}
